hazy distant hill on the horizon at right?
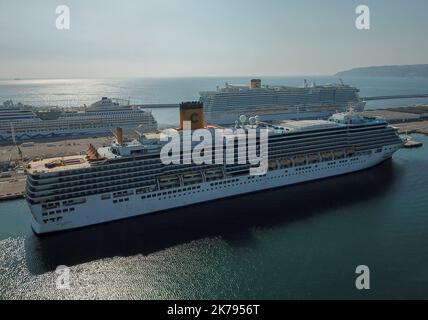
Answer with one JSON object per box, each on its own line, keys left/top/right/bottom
{"left": 335, "top": 64, "right": 428, "bottom": 77}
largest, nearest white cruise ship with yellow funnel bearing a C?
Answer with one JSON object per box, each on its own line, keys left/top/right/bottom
{"left": 26, "top": 103, "right": 402, "bottom": 234}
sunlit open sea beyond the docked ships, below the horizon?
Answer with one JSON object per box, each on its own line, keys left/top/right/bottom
{"left": 0, "top": 76, "right": 428, "bottom": 124}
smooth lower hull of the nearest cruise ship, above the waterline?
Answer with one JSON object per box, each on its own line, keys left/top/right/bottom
{"left": 30, "top": 144, "right": 401, "bottom": 234}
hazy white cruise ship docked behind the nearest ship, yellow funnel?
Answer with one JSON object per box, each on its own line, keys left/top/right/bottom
{"left": 200, "top": 79, "right": 366, "bottom": 125}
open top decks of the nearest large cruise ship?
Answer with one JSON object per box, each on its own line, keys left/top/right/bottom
{"left": 27, "top": 111, "right": 386, "bottom": 174}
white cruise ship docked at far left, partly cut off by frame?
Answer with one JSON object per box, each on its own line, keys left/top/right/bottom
{"left": 0, "top": 97, "right": 157, "bottom": 143}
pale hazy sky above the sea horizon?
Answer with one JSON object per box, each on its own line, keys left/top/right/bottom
{"left": 0, "top": 0, "right": 428, "bottom": 78}
